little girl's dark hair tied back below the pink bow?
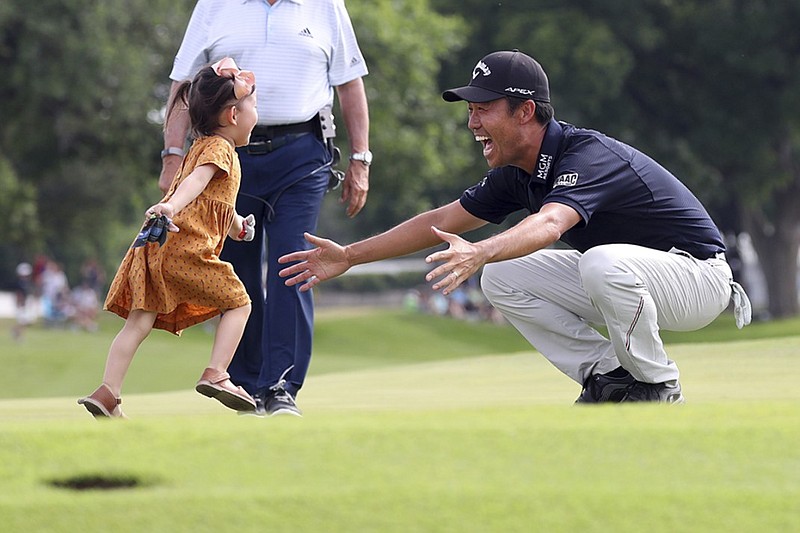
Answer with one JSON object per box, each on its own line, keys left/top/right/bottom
{"left": 164, "top": 63, "right": 244, "bottom": 139}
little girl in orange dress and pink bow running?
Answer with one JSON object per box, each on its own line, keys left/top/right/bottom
{"left": 78, "top": 58, "right": 258, "bottom": 418}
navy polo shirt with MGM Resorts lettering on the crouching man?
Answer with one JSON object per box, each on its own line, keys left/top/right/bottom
{"left": 460, "top": 120, "right": 725, "bottom": 259}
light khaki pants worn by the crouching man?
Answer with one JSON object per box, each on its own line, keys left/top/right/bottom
{"left": 481, "top": 244, "right": 732, "bottom": 384}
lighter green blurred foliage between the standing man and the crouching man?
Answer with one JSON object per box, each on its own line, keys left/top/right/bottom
{"left": 319, "top": 0, "right": 468, "bottom": 242}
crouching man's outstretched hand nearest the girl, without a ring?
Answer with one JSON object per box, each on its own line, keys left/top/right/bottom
{"left": 278, "top": 233, "right": 351, "bottom": 292}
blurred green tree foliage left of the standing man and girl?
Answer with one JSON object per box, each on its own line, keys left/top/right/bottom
{"left": 0, "top": 0, "right": 194, "bottom": 286}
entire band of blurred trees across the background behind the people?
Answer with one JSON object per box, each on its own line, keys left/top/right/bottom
{"left": 0, "top": 0, "right": 800, "bottom": 316}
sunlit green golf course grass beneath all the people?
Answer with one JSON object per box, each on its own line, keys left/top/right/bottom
{"left": 0, "top": 312, "right": 800, "bottom": 533}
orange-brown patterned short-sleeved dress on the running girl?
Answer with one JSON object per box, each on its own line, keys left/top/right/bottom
{"left": 104, "top": 135, "right": 250, "bottom": 335}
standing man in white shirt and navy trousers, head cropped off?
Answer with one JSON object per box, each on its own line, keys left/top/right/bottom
{"left": 166, "top": 0, "right": 372, "bottom": 416}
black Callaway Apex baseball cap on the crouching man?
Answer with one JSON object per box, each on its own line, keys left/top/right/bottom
{"left": 442, "top": 49, "right": 550, "bottom": 103}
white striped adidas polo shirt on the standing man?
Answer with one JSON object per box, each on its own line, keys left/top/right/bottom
{"left": 170, "top": 0, "right": 367, "bottom": 125}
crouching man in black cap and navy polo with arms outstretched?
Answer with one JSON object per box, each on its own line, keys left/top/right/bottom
{"left": 279, "top": 50, "right": 750, "bottom": 403}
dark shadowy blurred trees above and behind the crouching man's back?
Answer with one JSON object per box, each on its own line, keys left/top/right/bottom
{"left": 435, "top": 0, "right": 800, "bottom": 317}
